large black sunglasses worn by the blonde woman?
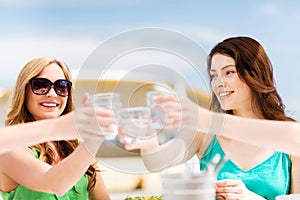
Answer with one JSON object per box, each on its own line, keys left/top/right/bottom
{"left": 29, "top": 78, "right": 72, "bottom": 97}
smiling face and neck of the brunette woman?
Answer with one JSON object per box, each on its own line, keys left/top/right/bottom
{"left": 210, "top": 54, "right": 257, "bottom": 117}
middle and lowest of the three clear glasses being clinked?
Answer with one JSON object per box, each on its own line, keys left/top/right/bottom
{"left": 118, "top": 106, "right": 152, "bottom": 143}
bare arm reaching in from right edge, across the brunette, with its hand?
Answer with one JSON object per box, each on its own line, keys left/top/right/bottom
{"left": 150, "top": 95, "right": 300, "bottom": 157}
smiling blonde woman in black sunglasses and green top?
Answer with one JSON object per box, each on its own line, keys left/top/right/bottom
{"left": 0, "top": 57, "right": 110, "bottom": 200}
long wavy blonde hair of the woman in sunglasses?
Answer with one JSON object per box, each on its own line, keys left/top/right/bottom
{"left": 5, "top": 57, "right": 97, "bottom": 191}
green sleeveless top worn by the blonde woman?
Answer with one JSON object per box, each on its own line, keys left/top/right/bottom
{"left": 0, "top": 149, "right": 88, "bottom": 200}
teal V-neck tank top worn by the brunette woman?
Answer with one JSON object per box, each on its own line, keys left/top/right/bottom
{"left": 200, "top": 137, "right": 291, "bottom": 200}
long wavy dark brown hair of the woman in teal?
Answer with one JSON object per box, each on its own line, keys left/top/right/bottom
{"left": 207, "top": 37, "right": 293, "bottom": 120}
